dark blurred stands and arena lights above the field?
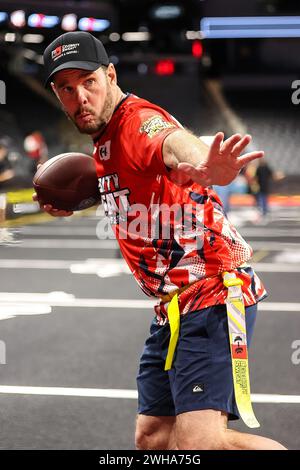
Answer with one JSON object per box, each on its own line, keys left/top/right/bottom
{"left": 0, "top": 0, "right": 300, "bottom": 213}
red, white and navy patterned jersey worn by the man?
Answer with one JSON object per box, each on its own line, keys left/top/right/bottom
{"left": 94, "top": 94, "right": 265, "bottom": 324}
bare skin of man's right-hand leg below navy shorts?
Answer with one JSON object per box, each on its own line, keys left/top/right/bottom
{"left": 176, "top": 410, "right": 286, "bottom": 450}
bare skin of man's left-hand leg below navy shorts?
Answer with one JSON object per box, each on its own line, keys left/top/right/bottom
{"left": 135, "top": 414, "right": 177, "bottom": 450}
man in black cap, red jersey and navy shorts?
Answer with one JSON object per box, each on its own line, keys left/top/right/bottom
{"left": 34, "top": 32, "right": 283, "bottom": 449}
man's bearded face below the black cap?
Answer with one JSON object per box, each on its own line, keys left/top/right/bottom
{"left": 52, "top": 65, "right": 116, "bottom": 135}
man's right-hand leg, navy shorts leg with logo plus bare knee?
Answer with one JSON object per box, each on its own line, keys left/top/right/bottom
{"left": 170, "top": 305, "right": 284, "bottom": 450}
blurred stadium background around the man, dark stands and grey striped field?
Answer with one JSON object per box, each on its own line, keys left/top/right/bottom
{"left": 0, "top": 0, "right": 300, "bottom": 448}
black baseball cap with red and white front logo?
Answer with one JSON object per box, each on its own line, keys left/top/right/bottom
{"left": 44, "top": 31, "right": 109, "bottom": 86}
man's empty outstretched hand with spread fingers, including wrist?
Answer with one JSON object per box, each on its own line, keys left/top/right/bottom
{"left": 177, "top": 132, "right": 264, "bottom": 186}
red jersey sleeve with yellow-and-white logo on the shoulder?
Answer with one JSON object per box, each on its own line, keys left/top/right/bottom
{"left": 121, "top": 108, "right": 183, "bottom": 175}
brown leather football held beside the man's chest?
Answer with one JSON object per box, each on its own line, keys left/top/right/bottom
{"left": 33, "top": 152, "right": 100, "bottom": 211}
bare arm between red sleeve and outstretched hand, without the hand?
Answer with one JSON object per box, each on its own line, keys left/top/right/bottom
{"left": 163, "top": 129, "right": 209, "bottom": 170}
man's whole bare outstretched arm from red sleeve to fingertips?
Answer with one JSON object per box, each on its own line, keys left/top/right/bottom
{"left": 163, "top": 129, "right": 264, "bottom": 187}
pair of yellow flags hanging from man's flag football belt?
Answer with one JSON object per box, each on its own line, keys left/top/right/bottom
{"left": 165, "top": 272, "right": 260, "bottom": 428}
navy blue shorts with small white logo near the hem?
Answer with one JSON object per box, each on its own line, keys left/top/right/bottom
{"left": 137, "top": 305, "right": 257, "bottom": 419}
